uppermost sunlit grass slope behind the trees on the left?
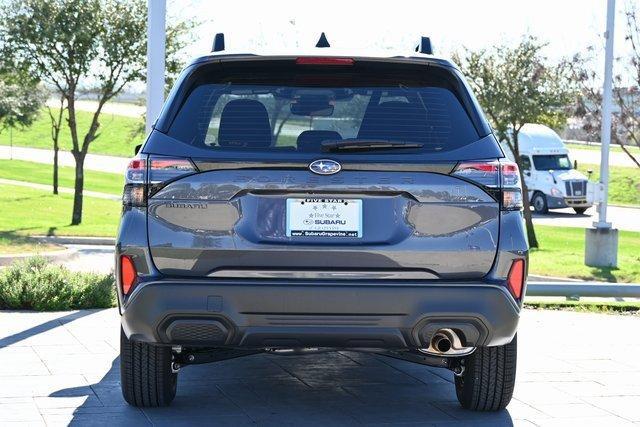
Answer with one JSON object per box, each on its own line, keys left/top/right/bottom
{"left": 0, "top": 109, "right": 143, "bottom": 157}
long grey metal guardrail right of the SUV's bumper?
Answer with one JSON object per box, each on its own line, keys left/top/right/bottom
{"left": 527, "top": 282, "right": 640, "bottom": 298}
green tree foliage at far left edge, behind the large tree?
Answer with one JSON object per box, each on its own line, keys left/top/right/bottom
{"left": 0, "top": 74, "right": 46, "bottom": 145}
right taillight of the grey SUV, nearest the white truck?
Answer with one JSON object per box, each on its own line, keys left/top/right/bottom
{"left": 452, "top": 160, "right": 522, "bottom": 211}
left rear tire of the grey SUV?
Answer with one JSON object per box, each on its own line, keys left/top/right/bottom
{"left": 120, "top": 329, "right": 178, "bottom": 407}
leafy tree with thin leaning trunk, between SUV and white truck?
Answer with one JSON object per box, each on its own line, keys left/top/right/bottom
{"left": 454, "top": 36, "right": 574, "bottom": 248}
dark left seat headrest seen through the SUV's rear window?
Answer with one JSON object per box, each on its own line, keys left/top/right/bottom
{"left": 218, "top": 99, "right": 271, "bottom": 148}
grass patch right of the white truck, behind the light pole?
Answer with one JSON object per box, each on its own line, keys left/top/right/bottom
{"left": 578, "top": 164, "right": 640, "bottom": 206}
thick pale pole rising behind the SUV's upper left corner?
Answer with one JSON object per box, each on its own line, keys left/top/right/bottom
{"left": 145, "top": 0, "right": 167, "bottom": 133}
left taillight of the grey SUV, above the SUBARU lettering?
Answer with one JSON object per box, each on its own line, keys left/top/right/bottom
{"left": 122, "top": 156, "right": 197, "bottom": 206}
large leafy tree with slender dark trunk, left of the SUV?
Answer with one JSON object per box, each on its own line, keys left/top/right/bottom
{"left": 0, "top": 0, "right": 190, "bottom": 225}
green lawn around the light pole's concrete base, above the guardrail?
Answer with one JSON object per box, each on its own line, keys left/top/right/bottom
{"left": 529, "top": 225, "right": 640, "bottom": 283}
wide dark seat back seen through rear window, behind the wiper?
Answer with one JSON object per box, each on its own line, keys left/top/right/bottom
{"left": 358, "top": 101, "right": 429, "bottom": 142}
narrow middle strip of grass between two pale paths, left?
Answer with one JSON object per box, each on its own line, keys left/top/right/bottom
{"left": 0, "top": 160, "right": 124, "bottom": 195}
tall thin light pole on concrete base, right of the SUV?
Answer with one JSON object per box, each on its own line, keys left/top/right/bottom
{"left": 585, "top": 0, "right": 618, "bottom": 267}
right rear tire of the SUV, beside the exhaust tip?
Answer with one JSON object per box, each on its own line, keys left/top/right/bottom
{"left": 455, "top": 337, "right": 517, "bottom": 412}
